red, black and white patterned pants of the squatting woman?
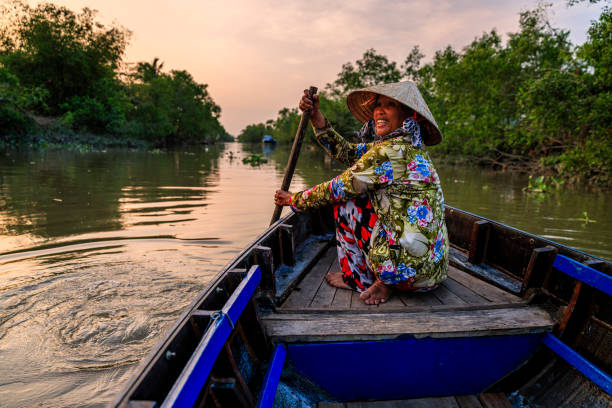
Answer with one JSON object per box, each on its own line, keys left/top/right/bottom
{"left": 334, "top": 195, "right": 438, "bottom": 292}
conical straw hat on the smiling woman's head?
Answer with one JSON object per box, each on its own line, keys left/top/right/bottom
{"left": 346, "top": 81, "right": 442, "bottom": 146}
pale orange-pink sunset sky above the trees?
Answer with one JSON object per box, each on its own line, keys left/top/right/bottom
{"left": 22, "top": 0, "right": 606, "bottom": 135}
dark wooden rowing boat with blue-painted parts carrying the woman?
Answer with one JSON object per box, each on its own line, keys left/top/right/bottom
{"left": 113, "top": 207, "right": 612, "bottom": 408}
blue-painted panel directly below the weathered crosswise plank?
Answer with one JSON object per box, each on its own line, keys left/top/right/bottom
{"left": 288, "top": 334, "right": 542, "bottom": 401}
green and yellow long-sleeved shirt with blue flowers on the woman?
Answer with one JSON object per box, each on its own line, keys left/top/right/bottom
{"left": 291, "top": 126, "right": 449, "bottom": 288}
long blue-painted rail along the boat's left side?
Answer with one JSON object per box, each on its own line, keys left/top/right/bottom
{"left": 162, "top": 265, "right": 261, "bottom": 407}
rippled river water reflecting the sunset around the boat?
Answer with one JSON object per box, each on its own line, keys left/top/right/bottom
{"left": 0, "top": 143, "right": 612, "bottom": 407}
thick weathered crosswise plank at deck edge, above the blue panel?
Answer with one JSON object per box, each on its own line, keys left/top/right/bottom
{"left": 262, "top": 307, "right": 554, "bottom": 341}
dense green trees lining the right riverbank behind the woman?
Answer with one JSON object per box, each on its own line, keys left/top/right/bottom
{"left": 238, "top": 5, "right": 612, "bottom": 188}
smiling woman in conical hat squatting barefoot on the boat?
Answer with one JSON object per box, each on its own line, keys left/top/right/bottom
{"left": 275, "top": 81, "right": 448, "bottom": 304}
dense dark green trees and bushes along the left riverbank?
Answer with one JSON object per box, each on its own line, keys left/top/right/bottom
{"left": 0, "top": 0, "right": 229, "bottom": 146}
